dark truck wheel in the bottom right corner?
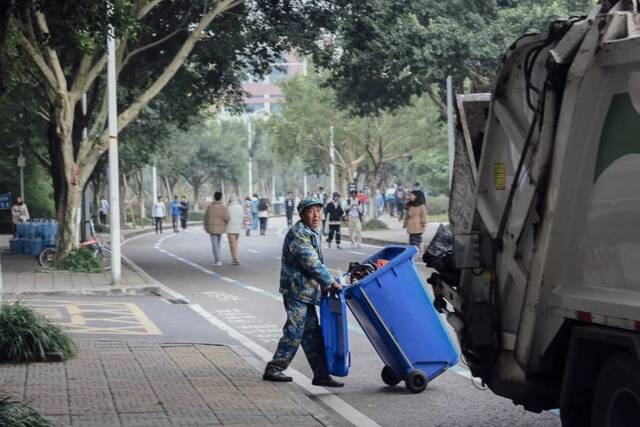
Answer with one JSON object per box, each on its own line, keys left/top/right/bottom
{"left": 591, "top": 354, "right": 640, "bottom": 427}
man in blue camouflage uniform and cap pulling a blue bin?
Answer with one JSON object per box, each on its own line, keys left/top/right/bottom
{"left": 262, "top": 198, "right": 343, "bottom": 387}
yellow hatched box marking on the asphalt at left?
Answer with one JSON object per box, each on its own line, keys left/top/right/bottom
{"left": 27, "top": 299, "right": 162, "bottom": 335}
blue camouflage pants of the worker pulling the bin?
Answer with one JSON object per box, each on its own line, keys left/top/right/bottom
{"left": 267, "top": 297, "right": 329, "bottom": 377}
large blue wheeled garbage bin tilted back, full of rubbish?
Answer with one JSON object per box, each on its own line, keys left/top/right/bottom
{"left": 345, "top": 246, "right": 459, "bottom": 393}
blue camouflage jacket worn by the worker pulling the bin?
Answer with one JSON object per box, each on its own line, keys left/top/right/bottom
{"left": 280, "top": 221, "right": 335, "bottom": 305}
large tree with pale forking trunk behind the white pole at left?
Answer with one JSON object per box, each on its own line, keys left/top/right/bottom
{"left": 1, "top": 0, "right": 344, "bottom": 253}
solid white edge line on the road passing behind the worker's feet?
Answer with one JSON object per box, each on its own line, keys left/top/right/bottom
{"left": 189, "top": 304, "right": 380, "bottom": 427}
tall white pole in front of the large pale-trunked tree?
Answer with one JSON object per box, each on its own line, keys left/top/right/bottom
{"left": 107, "top": 1, "right": 122, "bottom": 286}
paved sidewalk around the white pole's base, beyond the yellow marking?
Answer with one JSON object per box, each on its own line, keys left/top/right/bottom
{"left": 0, "top": 235, "right": 159, "bottom": 296}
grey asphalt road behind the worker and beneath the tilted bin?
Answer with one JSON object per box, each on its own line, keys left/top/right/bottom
{"left": 123, "top": 218, "right": 560, "bottom": 426}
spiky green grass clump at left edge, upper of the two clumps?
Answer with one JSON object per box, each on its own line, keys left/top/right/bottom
{"left": 0, "top": 302, "right": 76, "bottom": 362}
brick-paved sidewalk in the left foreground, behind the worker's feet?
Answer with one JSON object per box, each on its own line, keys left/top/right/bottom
{"left": 0, "top": 340, "right": 331, "bottom": 427}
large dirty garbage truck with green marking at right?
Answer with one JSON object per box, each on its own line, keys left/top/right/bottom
{"left": 427, "top": 0, "right": 640, "bottom": 426}
